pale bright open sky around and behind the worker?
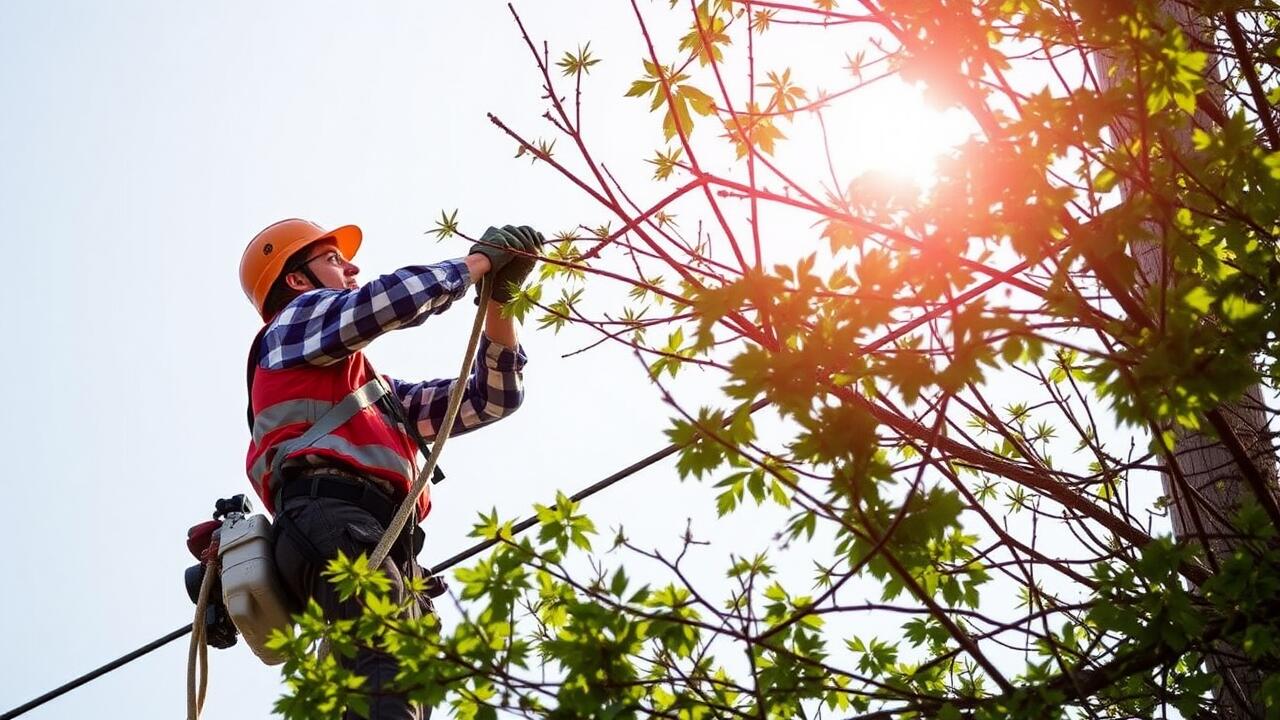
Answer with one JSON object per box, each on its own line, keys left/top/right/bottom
{"left": 0, "top": 0, "right": 1054, "bottom": 720}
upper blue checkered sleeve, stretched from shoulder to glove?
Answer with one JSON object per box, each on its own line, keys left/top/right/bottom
{"left": 259, "top": 260, "right": 471, "bottom": 370}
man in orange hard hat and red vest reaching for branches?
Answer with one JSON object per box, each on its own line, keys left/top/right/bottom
{"left": 241, "top": 219, "right": 543, "bottom": 720}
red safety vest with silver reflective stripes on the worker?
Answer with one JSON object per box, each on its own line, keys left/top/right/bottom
{"left": 244, "top": 343, "right": 431, "bottom": 519}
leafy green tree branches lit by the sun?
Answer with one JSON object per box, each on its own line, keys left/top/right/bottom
{"left": 282, "top": 0, "right": 1280, "bottom": 719}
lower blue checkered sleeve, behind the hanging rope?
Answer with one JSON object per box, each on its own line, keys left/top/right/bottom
{"left": 388, "top": 337, "right": 527, "bottom": 441}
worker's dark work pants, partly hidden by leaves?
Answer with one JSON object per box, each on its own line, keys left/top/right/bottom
{"left": 275, "top": 497, "right": 431, "bottom": 720}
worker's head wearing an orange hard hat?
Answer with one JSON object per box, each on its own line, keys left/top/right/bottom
{"left": 241, "top": 219, "right": 361, "bottom": 320}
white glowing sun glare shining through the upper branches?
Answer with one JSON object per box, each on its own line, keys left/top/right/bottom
{"left": 845, "top": 78, "right": 975, "bottom": 188}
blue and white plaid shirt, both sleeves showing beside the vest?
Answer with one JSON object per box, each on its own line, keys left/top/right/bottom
{"left": 257, "top": 260, "right": 527, "bottom": 441}
